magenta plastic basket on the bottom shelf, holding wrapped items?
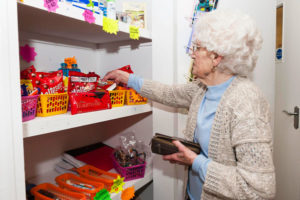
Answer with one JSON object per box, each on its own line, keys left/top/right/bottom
{"left": 111, "top": 154, "right": 146, "bottom": 181}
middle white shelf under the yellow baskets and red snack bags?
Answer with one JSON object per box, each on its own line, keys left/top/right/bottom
{"left": 23, "top": 104, "right": 152, "bottom": 138}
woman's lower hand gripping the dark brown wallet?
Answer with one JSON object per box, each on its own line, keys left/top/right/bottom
{"left": 163, "top": 141, "right": 197, "bottom": 166}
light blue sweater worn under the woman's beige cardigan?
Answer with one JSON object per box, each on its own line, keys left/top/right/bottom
{"left": 128, "top": 74, "right": 234, "bottom": 200}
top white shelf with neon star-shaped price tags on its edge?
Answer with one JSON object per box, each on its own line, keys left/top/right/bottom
{"left": 18, "top": 0, "right": 151, "bottom": 44}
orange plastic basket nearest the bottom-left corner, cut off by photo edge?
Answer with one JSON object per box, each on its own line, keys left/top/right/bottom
{"left": 31, "top": 183, "right": 86, "bottom": 200}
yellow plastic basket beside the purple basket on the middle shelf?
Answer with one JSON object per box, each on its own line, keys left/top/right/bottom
{"left": 37, "top": 93, "right": 69, "bottom": 117}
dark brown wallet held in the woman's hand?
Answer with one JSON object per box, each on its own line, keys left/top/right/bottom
{"left": 151, "top": 133, "right": 201, "bottom": 155}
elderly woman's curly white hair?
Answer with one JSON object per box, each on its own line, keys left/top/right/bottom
{"left": 193, "top": 10, "right": 263, "bottom": 76}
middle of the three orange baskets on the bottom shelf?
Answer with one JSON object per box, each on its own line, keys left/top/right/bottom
{"left": 55, "top": 173, "right": 104, "bottom": 200}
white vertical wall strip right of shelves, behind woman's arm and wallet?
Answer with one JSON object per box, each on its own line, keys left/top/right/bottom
{"left": 152, "top": 0, "right": 177, "bottom": 200}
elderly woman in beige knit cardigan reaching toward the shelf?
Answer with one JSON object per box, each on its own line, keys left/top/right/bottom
{"left": 104, "top": 10, "right": 275, "bottom": 200}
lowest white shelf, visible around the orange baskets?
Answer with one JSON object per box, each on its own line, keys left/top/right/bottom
{"left": 28, "top": 164, "right": 153, "bottom": 200}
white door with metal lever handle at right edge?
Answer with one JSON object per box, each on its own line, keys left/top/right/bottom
{"left": 274, "top": 0, "right": 300, "bottom": 200}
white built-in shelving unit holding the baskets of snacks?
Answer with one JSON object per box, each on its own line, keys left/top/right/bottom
{"left": 17, "top": 0, "right": 153, "bottom": 200}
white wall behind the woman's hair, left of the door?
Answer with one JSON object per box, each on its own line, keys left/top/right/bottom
{"left": 219, "top": 0, "right": 276, "bottom": 127}
